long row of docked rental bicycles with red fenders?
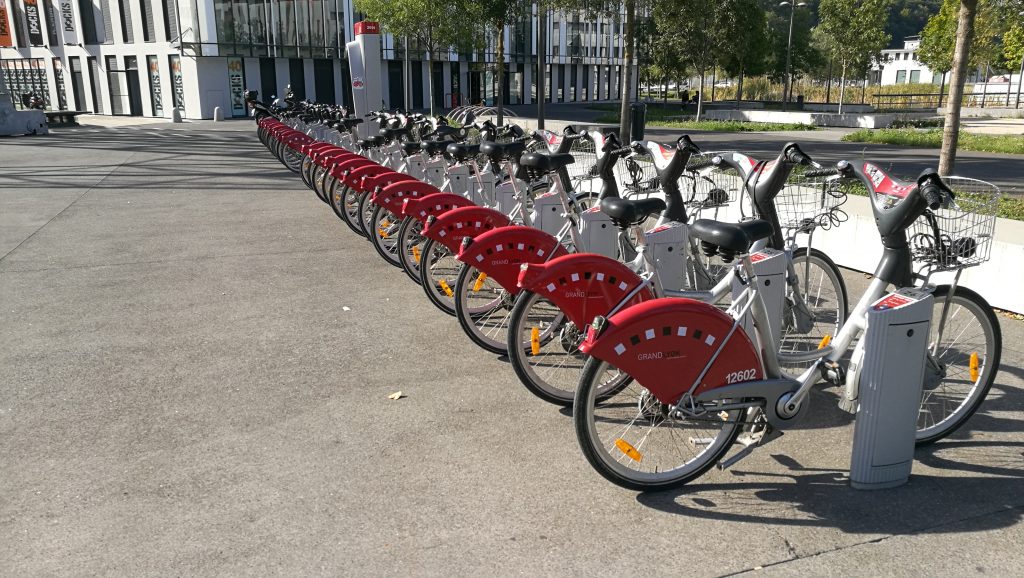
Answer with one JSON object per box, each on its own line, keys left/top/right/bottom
{"left": 251, "top": 104, "right": 1001, "bottom": 490}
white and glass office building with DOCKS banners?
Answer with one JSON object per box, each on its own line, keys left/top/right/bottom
{"left": 0, "top": 0, "right": 635, "bottom": 119}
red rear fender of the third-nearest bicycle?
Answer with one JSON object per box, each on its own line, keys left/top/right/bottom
{"left": 456, "top": 225, "right": 568, "bottom": 295}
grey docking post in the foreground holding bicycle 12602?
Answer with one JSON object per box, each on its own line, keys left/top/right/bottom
{"left": 847, "top": 289, "right": 934, "bottom": 490}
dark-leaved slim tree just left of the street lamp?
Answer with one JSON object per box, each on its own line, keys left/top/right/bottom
{"left": 719, "top": 0, "right": 770, "bottom": 102}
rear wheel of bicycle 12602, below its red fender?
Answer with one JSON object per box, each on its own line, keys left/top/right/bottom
{"left": 572, "top": 358, "right": 743, "bottom": 491}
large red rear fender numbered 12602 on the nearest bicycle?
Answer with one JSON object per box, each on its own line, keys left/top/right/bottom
{"left": 580, "top": 297, "right": 764, "bottom": 404}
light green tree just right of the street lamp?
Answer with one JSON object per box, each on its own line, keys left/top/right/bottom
{"left": 818, "top": 0, "right": 892, "bottom": 114}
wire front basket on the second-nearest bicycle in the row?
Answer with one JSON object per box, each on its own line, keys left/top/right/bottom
{"left": 775, "top": 170, "right": 851, "bottom": 233}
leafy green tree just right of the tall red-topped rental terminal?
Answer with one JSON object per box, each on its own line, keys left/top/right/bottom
{"left": 354, "top": 0, "right": 467, "bottom": 115}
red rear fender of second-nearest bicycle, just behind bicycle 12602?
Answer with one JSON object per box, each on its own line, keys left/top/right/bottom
{"left": 518, "top": 253, "right": 654, "bottom": 328}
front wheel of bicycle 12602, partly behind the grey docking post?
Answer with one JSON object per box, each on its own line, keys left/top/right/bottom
{"left": 916, "top": 285, "right": 1002, "bottom": 446}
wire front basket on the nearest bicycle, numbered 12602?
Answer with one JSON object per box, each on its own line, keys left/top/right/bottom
{"left": 907, "top": 176, "right": 999, "bottom": 272}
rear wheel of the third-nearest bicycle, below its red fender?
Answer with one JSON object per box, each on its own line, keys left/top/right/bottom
{"left": 455, "top": 265, "right": 515, "bottom": 356}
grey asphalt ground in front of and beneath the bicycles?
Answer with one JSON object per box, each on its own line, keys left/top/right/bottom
{"left": 0, "top": 122, "right": 1024, "bottom": 576}
